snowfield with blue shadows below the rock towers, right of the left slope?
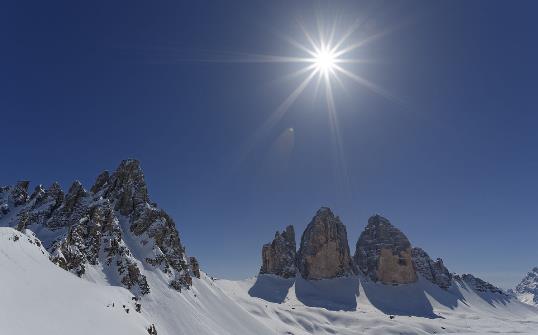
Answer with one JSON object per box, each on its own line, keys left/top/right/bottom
{"left": 217, "top": 275, "right": 538, "bottom": 335}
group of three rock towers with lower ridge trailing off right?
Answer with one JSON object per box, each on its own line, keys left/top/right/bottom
{"left": 260, "top": 207, "right": 504, "bottom": 294}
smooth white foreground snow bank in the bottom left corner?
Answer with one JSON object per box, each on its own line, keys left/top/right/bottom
{"left": 0, "top": 228, "right": 152, "bottom": 335}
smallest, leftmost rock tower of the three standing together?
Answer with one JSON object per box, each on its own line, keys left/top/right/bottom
{"left": 260, "top": 226, "right": 297, "bottom": 278}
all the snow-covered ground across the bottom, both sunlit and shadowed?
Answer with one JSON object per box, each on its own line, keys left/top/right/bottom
{"left": 0, "top": 228, "right": 538, "bottom": 335}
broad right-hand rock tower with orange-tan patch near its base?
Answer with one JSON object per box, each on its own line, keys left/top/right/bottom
{"left": 354, "top": 215, "right": 417, "bottom": 284}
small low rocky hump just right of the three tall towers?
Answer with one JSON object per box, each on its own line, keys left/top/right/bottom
{"left": 411, "top": 248, "right": 452, "bottom": 289}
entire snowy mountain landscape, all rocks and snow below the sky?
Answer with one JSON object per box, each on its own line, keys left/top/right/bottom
{"left": 0, "top": 160, "right": 538, "bottom": 335}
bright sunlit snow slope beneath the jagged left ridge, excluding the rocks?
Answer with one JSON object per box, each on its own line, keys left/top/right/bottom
{"left": 0, "top": 227, "right": 274, "bottom": 335}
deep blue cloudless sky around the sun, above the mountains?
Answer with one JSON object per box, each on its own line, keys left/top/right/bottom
{"left": 0, "top": 1, "right": 538, "bottom": 287}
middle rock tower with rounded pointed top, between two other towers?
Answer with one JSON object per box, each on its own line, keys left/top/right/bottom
{"left": 297, "top": 207, "right": 354, "bottom": 279}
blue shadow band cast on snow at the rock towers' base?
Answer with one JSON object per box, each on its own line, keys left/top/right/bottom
{"left": 248, "top": 275, "right": 510, "bottom": 319}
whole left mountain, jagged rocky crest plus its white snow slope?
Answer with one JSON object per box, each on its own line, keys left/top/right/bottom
{"left": 0, "top": 160, "right": 273, "bottom": 335}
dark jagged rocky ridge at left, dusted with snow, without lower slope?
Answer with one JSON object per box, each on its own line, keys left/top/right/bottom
{"left": 0, "top": 160, "right": 200, "bottom": 295}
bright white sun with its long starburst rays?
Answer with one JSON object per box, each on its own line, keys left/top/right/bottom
{"left": 230, "top": 17, "right": 397, "bottom": 184}
